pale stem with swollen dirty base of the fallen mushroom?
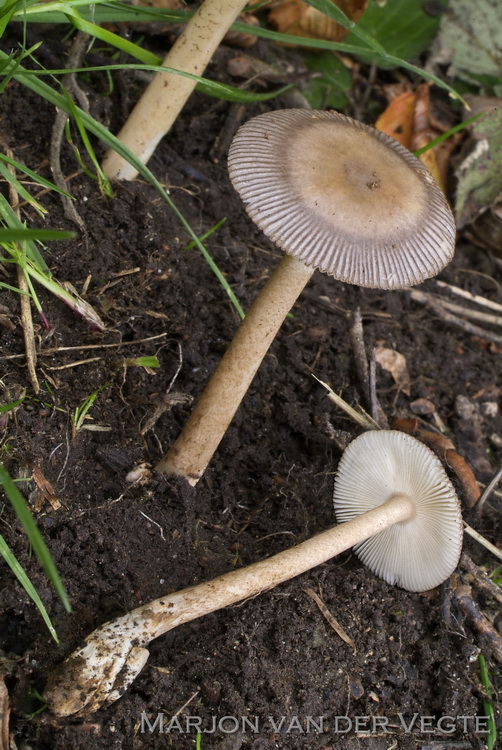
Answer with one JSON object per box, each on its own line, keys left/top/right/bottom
{"left": 44, "top": 494, "right": 415, "bottom": 717}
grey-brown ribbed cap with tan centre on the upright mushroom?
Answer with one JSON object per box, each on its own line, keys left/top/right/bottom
{"left": 228, "top": 109, "right": 455, "bottom": 289}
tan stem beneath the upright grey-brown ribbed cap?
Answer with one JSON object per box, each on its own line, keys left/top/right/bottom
{"left": 155, "top": 255, "right": 314, "bottom": 486}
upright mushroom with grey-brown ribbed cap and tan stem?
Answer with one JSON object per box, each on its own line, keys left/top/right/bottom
{"left": 156, "top": 109, "right": 455, "bottom": 485}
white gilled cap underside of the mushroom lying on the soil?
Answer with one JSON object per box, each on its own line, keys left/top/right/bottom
{"left": 333, "top": 430, "right": 463, "bottom": 591}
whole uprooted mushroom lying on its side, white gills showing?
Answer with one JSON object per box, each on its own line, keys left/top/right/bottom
{"left": 44, "top": 430, "right": 463, "bottom": 717}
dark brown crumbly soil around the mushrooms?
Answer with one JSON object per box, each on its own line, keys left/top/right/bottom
{"left": 0, "top": 20, "right": 502, "bottom": 750}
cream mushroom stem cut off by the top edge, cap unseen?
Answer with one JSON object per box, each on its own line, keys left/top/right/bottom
{"left": 102, "top": 0, "right": 246, "bottom": 180}
